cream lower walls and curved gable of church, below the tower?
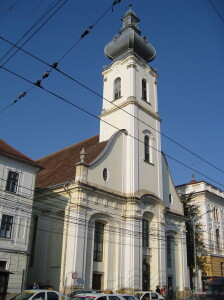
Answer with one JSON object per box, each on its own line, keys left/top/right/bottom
{"left": 29, "top": 132, "right": 188, "bottom": 295}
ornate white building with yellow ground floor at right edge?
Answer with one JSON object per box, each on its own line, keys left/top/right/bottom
{"left": 177, "top": 180, "right": 224, "bottom": 288}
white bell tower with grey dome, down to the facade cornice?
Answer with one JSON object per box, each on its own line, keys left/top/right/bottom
{"left": 100, "top": 6, "right": 162, "bottom": 197}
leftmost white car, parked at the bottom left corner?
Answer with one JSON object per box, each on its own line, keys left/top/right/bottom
{"left": 12, "top": 289, "right": 65, "bottom": 300}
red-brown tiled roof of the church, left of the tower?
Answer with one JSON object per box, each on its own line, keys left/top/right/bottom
{"left": 36, "top": 135, "right": 107, "bottom": 188}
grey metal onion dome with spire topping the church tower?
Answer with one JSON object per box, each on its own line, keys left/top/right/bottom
{"left": 104, "top": 5, "right": 156, "bottom": 62}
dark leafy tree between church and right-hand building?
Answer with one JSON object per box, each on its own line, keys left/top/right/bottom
{"left": 181, "top": 193, "right": 207, "bottom": 289}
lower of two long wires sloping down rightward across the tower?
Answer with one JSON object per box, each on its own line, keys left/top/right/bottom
{"left": 1, "top": 66, "right": 224, "bottom": 187}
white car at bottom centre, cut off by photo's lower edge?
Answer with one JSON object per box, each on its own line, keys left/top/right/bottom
{"left": 70, "top": 293, "right": 138, "bottom": 300}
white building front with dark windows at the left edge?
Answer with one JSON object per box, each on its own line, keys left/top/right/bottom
{"left": 0, "top": 141, "right": 37, "bottom": 293}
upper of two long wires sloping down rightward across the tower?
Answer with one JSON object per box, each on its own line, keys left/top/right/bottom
{"left": 0, "top": 36, "right": 224, "bottom": 179}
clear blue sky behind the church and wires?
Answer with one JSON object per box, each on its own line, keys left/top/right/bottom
{"left": 0, "top": 0, "right": 224, "bottom": 190}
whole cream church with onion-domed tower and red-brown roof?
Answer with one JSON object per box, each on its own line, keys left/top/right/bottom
{"left": 28, "top": 8, "right": 189, "bottom": 297}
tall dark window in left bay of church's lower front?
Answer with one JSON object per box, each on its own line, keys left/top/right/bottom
{"left": 93, "top": 221, "right": 104, "bottom": 261}
